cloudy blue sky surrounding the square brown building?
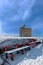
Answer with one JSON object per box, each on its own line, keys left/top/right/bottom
{"left": 0, "top": 0, "right": 43, "bottom": 36}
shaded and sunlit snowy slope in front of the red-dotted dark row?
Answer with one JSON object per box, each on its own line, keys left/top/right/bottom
{"left": 5, "top": 43, "right": 43, "bottom": 65}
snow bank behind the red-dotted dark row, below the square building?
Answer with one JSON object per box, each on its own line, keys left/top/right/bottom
{"left": 0, "top": 35, "right": 43, "bottom": 47}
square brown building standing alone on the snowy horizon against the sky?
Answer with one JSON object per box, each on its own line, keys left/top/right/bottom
{"left": 20, "top": 25, "right": 32, "bottom": 37}
